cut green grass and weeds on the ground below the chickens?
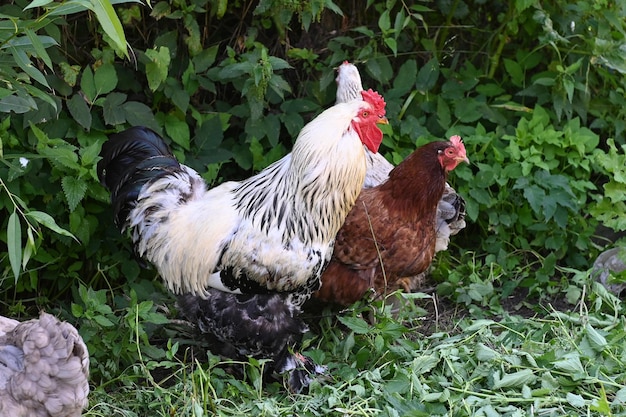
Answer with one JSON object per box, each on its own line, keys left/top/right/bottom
{"left": 85, "top": 274, "right": 626, "bottom": 417}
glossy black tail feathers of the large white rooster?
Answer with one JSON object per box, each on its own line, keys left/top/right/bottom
{"left": 98, "top": 126, "right": 180, "bottom": 229}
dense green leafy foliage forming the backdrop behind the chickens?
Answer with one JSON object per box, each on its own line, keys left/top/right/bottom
{"left": 0, "top": 0, "right": 626, "bottom": 415}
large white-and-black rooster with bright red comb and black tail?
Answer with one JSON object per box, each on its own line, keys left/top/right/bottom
{"left": 98, "top": 90, "right": 387, "bottom": 391}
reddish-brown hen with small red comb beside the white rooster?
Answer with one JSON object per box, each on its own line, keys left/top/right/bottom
{"left": 313, "top": 136, "right": 469, "bottom": 306}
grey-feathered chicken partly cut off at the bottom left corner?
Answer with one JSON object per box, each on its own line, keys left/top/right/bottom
{"left": 0, "top": 313, "right": 89, "bottom": 417}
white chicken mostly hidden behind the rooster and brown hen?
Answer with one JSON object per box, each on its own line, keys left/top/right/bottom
{"left": 335, "top": 61, "right": 465, "bottom": 292}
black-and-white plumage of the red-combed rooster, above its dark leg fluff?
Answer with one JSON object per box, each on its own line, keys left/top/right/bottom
{"left": 98, "top": 100, "right": 378, "bottom": 295}
